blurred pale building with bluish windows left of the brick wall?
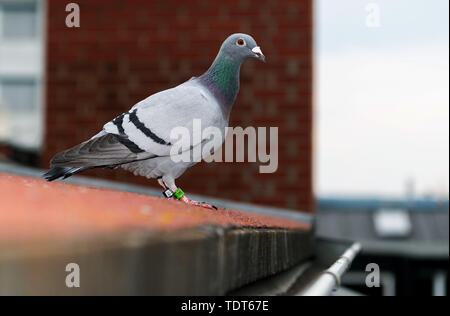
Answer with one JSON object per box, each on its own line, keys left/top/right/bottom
{"left": 0, "top": 0, "right": 44, "bottom": 152}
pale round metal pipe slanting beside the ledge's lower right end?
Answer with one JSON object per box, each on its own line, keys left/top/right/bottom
{"left": 298, "top": 243, "right": 361, "bottom": 296}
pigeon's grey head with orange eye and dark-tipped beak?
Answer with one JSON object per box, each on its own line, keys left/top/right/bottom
{"left": 220, "top": 33, "right": 266, "bottom": 62}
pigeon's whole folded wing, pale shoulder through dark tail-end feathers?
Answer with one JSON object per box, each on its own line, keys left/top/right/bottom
{"left": 51, "top": 81, "right": 223, "bottom": 173}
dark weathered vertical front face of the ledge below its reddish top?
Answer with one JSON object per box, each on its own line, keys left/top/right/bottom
{"left": 0, "top": 227, "right": 312, "bottom": 295}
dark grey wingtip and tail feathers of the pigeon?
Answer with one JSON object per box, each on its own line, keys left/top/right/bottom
{"left": 51, "top": 133, "right": 152, "bottom": 167}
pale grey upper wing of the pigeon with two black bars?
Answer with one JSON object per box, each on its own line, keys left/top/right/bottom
{"left": 103, "top": 80, "right": 226, "bottom": 156}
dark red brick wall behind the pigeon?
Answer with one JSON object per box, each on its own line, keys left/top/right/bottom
{"left": 43, "top": 0, "right": 314, "bottom": 211}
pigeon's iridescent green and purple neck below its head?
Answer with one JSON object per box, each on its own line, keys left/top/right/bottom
{"left": 199, "top": 52, "right": 241, "bottom": 115}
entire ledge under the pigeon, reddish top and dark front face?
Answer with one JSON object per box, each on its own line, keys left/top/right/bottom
{"left": 0, "top": 174, "right": 312, "bottom": 295}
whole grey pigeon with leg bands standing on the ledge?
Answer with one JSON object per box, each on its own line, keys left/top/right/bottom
{"left": 43, "top": 33, "right": 265, "bottom": 209}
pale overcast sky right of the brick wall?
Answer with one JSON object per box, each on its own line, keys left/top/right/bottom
{"left": 315, "top": 0, "right": 449, "bottom": 198}
